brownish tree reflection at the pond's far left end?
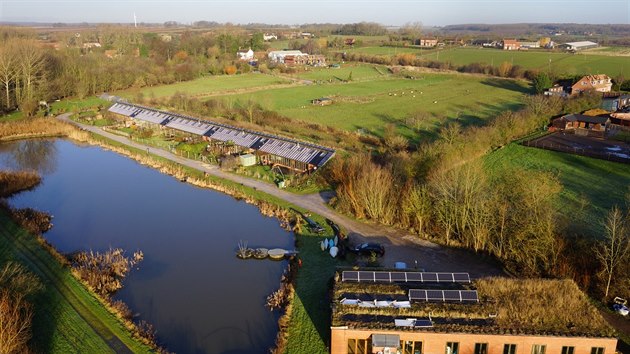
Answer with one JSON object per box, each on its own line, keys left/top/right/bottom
{"left": 0, "top": 139, "right": 57, "bottom": 176}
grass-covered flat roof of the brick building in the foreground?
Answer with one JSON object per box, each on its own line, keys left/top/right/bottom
{"left": 332, "top": 274, "right": 615, "bottom": 338}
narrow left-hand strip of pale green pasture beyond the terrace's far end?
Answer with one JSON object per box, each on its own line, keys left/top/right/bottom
{"left": 117, "top": 73, "right": 289, "bottom": 100}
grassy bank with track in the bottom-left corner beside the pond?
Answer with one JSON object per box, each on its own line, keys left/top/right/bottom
{"left": 0, "top": 211, "right": 151, "bottom": 354}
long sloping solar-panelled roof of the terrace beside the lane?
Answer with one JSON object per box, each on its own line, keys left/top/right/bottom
{"left": 109, "top": 102, "right": 335, "bottom": 167}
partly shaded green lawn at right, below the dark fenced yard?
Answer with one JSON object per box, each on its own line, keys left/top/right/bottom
{"left": 484, "top": 143, "right": 630, "bottom": 237}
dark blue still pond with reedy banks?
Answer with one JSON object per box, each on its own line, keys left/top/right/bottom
{"left": 0, "top": 140, "right": 293, "bottom": 353}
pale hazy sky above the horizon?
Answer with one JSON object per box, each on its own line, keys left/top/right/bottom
{"left": 0, "top": 0, "right": 630, "bottom": 26}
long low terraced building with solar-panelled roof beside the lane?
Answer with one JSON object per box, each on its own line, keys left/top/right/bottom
{"left": 109, "top": 101, "right": 335, "bottom": 173}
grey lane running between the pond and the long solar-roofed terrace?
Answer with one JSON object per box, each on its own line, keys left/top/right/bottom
{"left": 57, "top": 113, "right": 502, "bottom": 277}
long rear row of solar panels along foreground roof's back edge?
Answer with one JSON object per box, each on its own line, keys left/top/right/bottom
{"left": 341, "top": 271, "right": 470, "bottom": 283}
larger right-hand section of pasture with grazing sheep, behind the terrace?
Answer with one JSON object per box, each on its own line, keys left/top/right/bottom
{"left": 220, "top": 67, "right": 529, "bottom": 139}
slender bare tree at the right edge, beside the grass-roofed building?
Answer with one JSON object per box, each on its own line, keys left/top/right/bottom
{"left": 595, "top": 206, "right": 630, "bottom": 299}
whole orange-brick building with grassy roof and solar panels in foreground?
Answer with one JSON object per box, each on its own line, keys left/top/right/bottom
{"left": 330, "top": 270, "right": 617, "bottom": 354}
